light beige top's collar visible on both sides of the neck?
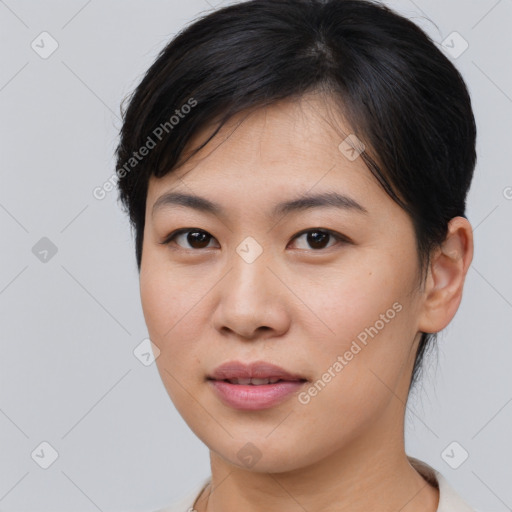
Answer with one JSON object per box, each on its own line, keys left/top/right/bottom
{"left": 155, "top": 457, "right": 476, "bottom": 512}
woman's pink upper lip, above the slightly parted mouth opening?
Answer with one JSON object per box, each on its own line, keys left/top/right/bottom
{"left": 207, "top": 361, "right": 307, "bottom": 385}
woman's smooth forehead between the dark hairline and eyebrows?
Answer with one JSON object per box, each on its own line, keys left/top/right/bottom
{"left": 148, "top": 94, "right": 376, "bottom": 200}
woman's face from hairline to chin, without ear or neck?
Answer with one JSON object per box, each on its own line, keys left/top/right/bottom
{"left": 140, "top": 97, "right": 428, "bottom": 472}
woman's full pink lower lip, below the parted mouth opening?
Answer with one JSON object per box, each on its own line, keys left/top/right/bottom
{"left": 208, "top": 380, "right": 305, "bottom": 411}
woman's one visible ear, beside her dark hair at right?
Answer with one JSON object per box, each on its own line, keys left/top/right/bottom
{"left": 418, "top": 217, "right": 473, "bottom": 333}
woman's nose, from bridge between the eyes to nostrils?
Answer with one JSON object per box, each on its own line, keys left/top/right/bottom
{"left": 212, "top": 248, "right": 290, "bottom": 340}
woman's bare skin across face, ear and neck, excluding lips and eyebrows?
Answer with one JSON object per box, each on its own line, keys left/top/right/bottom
{"left": 140, "top": 95, "right": 473, "bottom": 512}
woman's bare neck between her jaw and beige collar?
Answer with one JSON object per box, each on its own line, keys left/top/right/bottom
{"left": 194, "top": 420, "right": 439, "bottom": 512}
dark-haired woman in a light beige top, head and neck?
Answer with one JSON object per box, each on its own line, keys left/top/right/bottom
{"left": 117, "top": 0, "right": 476, "bottom": 512}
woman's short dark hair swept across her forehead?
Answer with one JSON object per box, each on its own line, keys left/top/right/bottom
{"left": 116, "top": 0, "right": 476, "bottom": 386}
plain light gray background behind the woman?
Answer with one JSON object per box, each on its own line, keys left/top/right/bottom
{"left": 0, "top": 0, "right": 512, "bottom": 512}
